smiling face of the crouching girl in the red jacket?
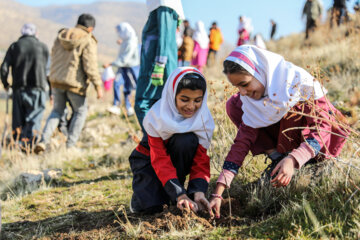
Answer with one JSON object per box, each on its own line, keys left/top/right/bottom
{"left": 175, "top": 88, "right": 204, "bottom": 118}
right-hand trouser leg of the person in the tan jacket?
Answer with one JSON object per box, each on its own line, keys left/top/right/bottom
{"left": 66, "top": 91, "right": 87, "bottom": 148}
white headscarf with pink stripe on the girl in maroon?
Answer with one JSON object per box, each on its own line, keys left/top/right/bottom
{"left": 226, "top": 45, "right": 326, "bottom": 128}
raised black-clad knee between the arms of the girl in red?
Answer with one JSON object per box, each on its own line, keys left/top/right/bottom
{"left": 166, "top": 132, "right": 199, "bottom": 185}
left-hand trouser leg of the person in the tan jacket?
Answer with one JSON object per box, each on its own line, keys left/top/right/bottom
{"left": 42, "top": 88, "right": 66, "bottom": 144}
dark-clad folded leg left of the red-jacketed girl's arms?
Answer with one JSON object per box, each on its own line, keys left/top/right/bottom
{"left": 129, "top": 141, "right": 170, "bottom": 213}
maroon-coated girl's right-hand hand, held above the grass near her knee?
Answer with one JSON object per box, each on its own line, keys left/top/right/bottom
{"left": 271, "top": 156, "right": 296, "bottom": 187}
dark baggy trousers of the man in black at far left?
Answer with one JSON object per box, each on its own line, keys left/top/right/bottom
{"left": 12, "top": 89, "right": 46, "bottom": 140}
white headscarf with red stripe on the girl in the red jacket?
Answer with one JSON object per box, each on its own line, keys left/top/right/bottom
{"left": 143, "top": 67, "right": 215, "bottom": 149}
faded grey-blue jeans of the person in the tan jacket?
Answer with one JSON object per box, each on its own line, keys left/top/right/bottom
{"left": 42, "top": 88, "right": 87, "bottom": 147}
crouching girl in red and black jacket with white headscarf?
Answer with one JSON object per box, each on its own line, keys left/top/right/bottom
{"left": 129, "top": 67, "right": 214, "bottom": 213}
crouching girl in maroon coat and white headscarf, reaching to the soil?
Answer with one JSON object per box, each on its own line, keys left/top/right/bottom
{"left": 210, "top": 45, "right": 347, "bottom": 218}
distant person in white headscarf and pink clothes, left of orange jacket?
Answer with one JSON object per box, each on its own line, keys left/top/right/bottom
{"left": 191, "top": 21, "right": 209, "bottom": 72}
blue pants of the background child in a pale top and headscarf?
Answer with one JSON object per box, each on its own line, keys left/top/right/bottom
{"left": 114, "top": 67, "right": 136, "bottom": 109}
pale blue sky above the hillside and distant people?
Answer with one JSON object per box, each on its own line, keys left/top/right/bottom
{"left": 17, "top": 0, "right": 355, "bottom": 44}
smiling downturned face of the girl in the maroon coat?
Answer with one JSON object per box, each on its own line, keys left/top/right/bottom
{"left": 226, "top": 73, "right": 265, "bottom": 100}
